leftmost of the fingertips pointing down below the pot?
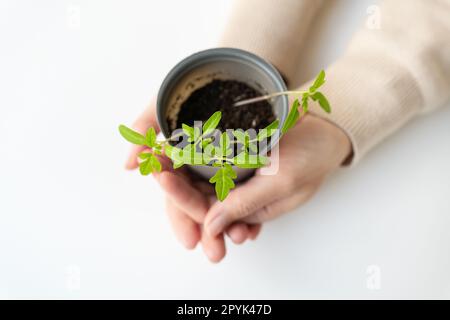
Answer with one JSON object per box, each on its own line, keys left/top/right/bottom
{"left": 166, "top": 199, "right": 201, "bottom": 249}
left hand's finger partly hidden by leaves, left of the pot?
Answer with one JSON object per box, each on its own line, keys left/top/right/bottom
{"left": 125, "top": 99, "right": 159, "bottom": 170}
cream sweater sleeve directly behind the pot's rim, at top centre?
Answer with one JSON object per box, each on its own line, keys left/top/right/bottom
{"left": 219, "top": 0, "right": 323, "bottom": 82}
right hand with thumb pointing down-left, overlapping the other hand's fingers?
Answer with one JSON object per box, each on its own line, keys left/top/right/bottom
{"left": 204, "top": 114, "right": 351, "bottom": 237}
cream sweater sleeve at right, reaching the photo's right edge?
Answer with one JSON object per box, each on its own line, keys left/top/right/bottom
{"left": 313, "top": 0, "right": 450, "bottom": 162}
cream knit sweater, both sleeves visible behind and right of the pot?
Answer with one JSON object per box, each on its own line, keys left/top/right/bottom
{"left": 220, "top": 0, "right": 450, "bottom": 162}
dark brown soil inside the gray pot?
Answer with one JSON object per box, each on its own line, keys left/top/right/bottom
{"left": 177, "top": 80, "right": 275, "bottom": 132}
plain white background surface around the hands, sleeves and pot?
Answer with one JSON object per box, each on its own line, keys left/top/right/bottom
{"left": 0, "top": 0, "right": 450, "bottom": 299}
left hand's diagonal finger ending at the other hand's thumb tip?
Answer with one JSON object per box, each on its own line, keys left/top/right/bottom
{"left": 157, "top": 171, "right": 209, "bottom": 223}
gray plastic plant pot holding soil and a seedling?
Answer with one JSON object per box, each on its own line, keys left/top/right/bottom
{"left": 156, "top": 48, "right": 289, "bottom": 181}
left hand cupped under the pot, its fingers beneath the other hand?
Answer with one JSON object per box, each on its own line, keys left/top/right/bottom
{"left": 126, "top": 101, "right": 261, "bottom": 262}
